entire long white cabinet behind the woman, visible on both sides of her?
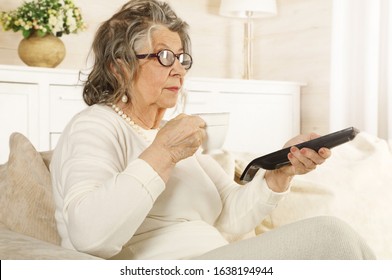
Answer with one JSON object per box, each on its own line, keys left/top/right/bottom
{"left": 0, "top": 65, "right": 301, "bottom": 163}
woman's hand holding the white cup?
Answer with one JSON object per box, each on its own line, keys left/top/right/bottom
{"left": 139, "top": 114, "right": 206, "bottom": 182}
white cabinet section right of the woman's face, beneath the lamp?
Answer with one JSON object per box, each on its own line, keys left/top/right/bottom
{"left": 179, "top": 78, "right": 301, "bottom": 155}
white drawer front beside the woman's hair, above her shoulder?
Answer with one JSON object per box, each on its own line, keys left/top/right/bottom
{"left": 49, "top": 85, "right": 87, "bottom": 132}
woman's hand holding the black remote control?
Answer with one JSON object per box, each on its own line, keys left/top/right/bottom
{"left": 265, "top": 133, "right": 331, "bottom": 192}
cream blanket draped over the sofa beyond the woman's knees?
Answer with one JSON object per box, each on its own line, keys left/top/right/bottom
{"left": 230, "top": 132, "right": 392, "bottom": 259}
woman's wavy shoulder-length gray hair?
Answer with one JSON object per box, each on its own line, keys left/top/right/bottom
{"left": 83, "top": 0, "right": 191, "bottom": 106}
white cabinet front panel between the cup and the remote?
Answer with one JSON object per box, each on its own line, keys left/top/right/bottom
{"left": 221, "top": 93, "right": 298, "bottom": 155}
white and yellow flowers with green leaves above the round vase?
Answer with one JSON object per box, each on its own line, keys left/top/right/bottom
{"left": 0, "top": 0, "right": 85, "bottom": 38}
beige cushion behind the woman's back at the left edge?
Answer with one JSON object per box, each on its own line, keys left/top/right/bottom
{"left": 0, "top": 133, "right": 60, "bottom": 244}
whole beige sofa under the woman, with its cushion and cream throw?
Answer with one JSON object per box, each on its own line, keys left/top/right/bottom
{"left": 0, "top": 133, "right": 392, "bottom": 260}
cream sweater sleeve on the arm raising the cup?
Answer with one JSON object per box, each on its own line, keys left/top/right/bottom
{"left": 51, "top": 107, "right": 165, "bottom": 258}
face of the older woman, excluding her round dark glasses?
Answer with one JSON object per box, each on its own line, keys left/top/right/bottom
{"left": 131, "top": 27, "right": 186, "bottom": 112}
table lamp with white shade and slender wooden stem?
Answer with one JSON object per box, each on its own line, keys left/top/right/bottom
{"left": 219, "top": 0, "right": 277, "bottom": 80}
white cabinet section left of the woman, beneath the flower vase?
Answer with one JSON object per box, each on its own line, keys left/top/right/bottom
{"left": 0, "top": 65, "right": 86, "bottom": 163}
